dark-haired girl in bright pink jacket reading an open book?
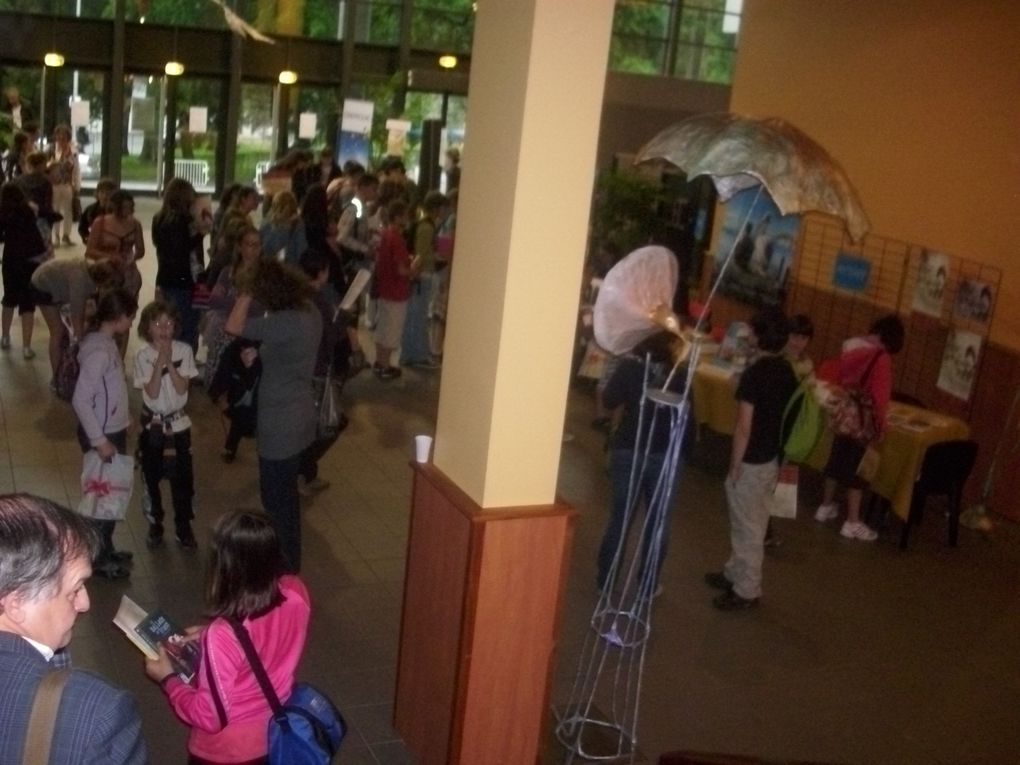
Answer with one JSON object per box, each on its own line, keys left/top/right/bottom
{"left": 146, "top": 510, "right": 311, "bottom": 765}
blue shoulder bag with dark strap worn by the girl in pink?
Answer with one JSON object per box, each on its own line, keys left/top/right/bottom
{"left": 210, "top": 619, "right": 347, "bottom": 765}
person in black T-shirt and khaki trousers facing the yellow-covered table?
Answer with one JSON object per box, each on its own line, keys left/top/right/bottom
{"left": 705, "top": 309, "right": 797, "bottom": 611}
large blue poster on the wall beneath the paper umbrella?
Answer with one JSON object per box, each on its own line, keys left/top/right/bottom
{"left": 713, "top": 189, "right": 801, "bottom": 307}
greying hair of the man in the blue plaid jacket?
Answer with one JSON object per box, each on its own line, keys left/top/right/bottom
{"left": 0, "top": 494, "right": 99, "bottom": 600}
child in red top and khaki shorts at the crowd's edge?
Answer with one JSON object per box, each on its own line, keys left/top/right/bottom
{"left": 372, "top": 199, "right": 416, "bottom": 379}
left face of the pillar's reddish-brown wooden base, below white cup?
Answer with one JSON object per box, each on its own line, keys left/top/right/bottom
{"left": 394, "top": 472, "right": 471, "bottom": 765}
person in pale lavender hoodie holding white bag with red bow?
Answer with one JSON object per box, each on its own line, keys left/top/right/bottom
{"left": 71, "top": 289, "right": 138, "bottom": 579}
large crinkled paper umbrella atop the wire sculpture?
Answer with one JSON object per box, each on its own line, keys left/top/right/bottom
{"left": 634, "top": 113, "right": 871, "bottom": 241}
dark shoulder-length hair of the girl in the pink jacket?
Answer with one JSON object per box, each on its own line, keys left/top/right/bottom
{"left": 205, "top": 510, "right": 285, "bottom": 619}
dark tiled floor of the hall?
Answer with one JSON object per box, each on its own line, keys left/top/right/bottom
{"left": 11, "top": 200, "right": 1020, "bottom": 765}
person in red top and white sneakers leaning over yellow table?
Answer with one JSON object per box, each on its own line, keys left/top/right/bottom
{"left": 815, "top": 314, "right": 906, "bottom": 542}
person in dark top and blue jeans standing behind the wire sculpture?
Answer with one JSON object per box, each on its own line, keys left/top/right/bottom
{"left": 596, "top": 332, "right": 683, "bottom": 595}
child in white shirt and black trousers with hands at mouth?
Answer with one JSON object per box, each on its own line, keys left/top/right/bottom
{"left": 135, "top": 300, "right": 198, "bottom": 549}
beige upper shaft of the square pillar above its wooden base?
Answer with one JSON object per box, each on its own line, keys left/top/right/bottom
{"left": 435, "top": 0, "right": 614, "bottom": 509}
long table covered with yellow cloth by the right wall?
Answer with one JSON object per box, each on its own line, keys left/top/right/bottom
{"left": 692, "top": 360, "right": 970, "bottom": 520}
